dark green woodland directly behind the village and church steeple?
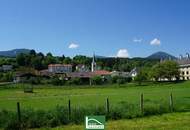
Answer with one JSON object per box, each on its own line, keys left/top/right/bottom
{"left": 16, "top": 50, "right": 159, "bottom": 72}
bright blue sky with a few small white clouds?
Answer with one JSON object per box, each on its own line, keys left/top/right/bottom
{"left": 0, "top": 0, "right": 190, "bottom": 57}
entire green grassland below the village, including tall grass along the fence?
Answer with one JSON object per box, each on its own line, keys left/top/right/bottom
{"left": 0, "top": 81, "right": 190, "bottom": 130}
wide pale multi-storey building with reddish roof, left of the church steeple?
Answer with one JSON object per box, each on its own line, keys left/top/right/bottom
{"left": 48, "top": 64, "right": 72, "bottom": 73}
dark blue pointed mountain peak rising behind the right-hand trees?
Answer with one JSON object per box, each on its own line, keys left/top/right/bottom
{"left": 147, "top": 51, "right": 177, "bottom": 60}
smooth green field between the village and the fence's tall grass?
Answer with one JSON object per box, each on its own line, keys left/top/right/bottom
{"left": 0, "top": 81, "right": 190, "bottom": 110}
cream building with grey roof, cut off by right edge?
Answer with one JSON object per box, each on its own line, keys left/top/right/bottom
{"left": 177, "top": 53, "right": 190, "bottom": 80}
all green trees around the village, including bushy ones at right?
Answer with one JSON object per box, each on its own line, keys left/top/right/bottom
{"left": 0, "top": 50, "right": 180, "bottom": 83}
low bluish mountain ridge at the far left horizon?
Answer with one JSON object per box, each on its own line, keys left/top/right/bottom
{"left": 0, "top": 49, "right": 30, "bottom": 57}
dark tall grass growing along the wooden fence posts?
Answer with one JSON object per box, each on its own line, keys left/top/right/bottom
{"left": 0, "top": 101, "right": 187, "bottom": 130}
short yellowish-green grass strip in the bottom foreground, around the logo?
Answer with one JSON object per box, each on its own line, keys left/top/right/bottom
{"left": 33, "top": 112, "right": 190, "bottom": 130}
